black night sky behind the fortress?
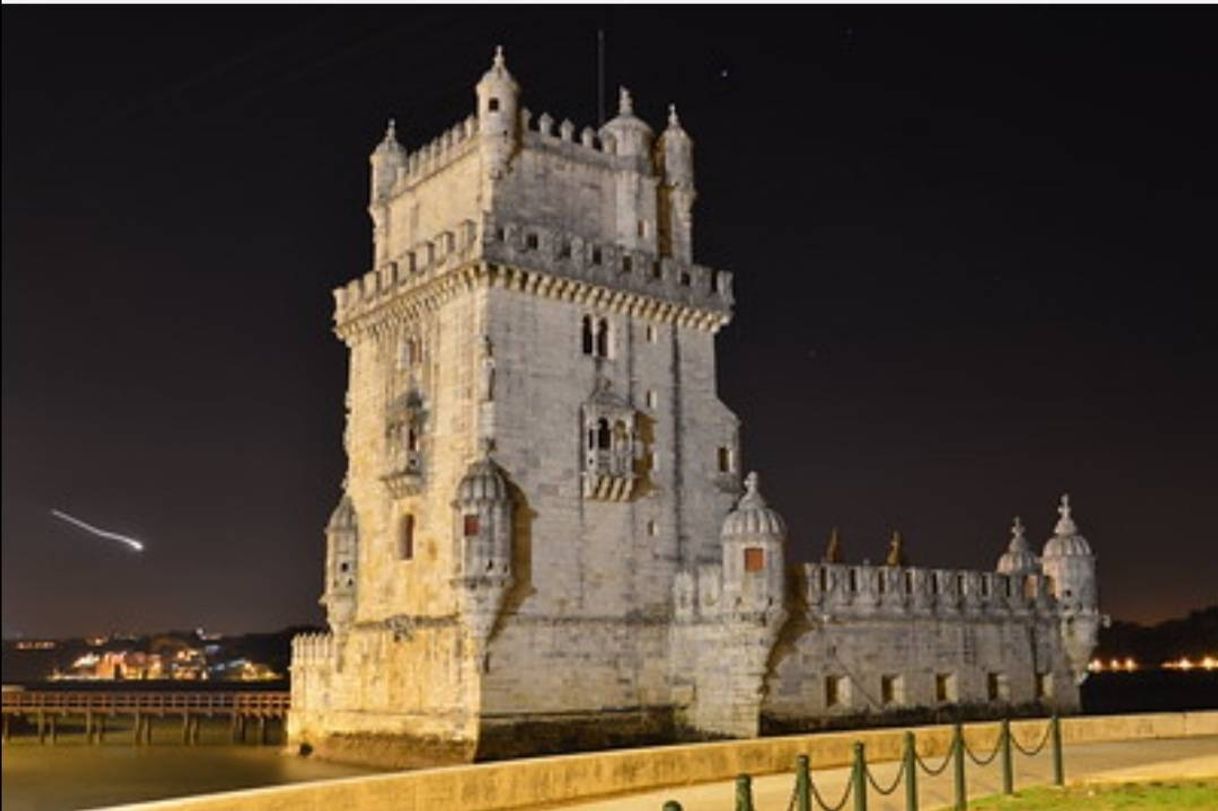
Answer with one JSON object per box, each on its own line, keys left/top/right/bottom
{"left": 2, "top": 6, "right": 1218, "bottom": 636}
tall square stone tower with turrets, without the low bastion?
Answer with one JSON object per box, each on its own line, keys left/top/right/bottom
{"left": 292, "top": 50, "right": 739, "bottom": 762}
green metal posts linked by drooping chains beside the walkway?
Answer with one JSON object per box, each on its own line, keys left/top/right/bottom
{"left": 663, "top": 715, "right": 1066, "bottom": 811}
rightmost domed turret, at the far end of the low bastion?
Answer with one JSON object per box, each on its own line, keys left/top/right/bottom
{"left": 1040, "top": 494, "right": 1101, "bottom": 684}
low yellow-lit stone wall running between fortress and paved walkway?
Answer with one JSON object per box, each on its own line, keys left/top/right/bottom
{"left": 104, "top": 711, "right": 1218, "bottom": 811}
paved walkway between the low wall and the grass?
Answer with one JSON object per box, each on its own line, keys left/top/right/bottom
{"left": 549, "top": 737, "right": 1218, "bottom": 811}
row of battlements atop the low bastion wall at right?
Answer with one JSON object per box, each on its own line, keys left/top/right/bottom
{"left": 799, "top": 564, "right": 1055, "bottom": 619}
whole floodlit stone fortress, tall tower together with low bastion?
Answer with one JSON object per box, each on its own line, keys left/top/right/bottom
{"left": 289, "top": 54, "right": 1097, "bottom": 765}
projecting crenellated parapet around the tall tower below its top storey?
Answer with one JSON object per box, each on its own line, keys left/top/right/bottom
{"left": 334, "top": 214, "right": 734, "bottom": 330}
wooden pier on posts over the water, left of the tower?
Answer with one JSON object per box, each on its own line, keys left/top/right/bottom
{"left": 4, "top": 690, "right": 291, "bottom": 744}
